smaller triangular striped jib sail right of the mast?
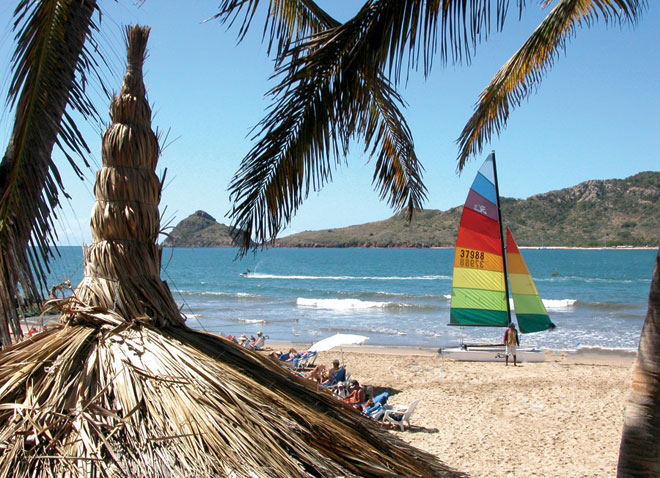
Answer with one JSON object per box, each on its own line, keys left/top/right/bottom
{"left": 506, "top": 227, "right": 554, "bottom": 334}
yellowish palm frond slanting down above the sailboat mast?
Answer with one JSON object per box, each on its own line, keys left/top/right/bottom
{"left": 458, "top": 0, "right": 646, "bottom": 171}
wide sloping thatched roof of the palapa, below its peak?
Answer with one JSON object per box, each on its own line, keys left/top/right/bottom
{"left": 0, "top": 316, "right": 463, "bottom": 477}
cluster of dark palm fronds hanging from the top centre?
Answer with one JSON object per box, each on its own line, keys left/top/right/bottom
{"left": 218, "top": 0, "right": 523, "bottom": 250}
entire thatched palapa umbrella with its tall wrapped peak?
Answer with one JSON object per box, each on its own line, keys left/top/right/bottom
{"left": 0, "top": 27, "right": 464, "bottom": 478}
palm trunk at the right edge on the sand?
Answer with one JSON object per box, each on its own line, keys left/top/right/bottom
{"left": 617, "top": 249, "right": 660, "bottom": 478}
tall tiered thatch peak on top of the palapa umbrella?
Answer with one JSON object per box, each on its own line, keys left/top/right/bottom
{"left": 76, "top": 28, "right": 183, "bottom": 326}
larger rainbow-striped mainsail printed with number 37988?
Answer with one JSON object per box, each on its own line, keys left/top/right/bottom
{"left": 449, "top": 153, "right": 510, "bottom": 327}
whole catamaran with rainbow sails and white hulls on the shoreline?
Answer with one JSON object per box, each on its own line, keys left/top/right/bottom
{"left": 439, "top": 152, "right": 555, "bottom": 362}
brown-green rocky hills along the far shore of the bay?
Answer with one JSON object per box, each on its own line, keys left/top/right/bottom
{"left": 164, "top": 172, "right": 660, "bottom": 247}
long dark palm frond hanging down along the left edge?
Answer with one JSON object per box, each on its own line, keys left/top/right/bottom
{"left": 0, "top": 0, "right": 96, "bottom": 343}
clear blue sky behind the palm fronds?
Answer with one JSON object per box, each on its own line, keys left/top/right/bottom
{"left": 0, "top": 0, "right": 660, "bottom": 245}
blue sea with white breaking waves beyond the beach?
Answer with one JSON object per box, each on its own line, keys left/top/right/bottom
{"left": 49, "top": 247, "right": 657, "bottom": 351}
